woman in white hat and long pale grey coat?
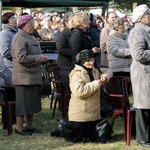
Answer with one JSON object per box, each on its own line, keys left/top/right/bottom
{"left": 129, "top": 4, "right": 150, "bottom": 147}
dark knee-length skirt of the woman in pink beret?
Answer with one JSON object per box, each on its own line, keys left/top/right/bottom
{"left": 15, "top": 85, "right": 41, "bottom": 116}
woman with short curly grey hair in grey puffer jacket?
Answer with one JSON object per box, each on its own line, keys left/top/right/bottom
{"left": 107, "top": 18, "right": 132, "bottom": 76}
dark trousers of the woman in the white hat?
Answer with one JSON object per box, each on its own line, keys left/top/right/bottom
{"left": 136, "top": 109, "right": 150, "bottom": 142}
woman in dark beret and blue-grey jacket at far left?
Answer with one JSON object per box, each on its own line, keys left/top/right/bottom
{"left": 0, "top": 12, "right": 17, "bottom": 72}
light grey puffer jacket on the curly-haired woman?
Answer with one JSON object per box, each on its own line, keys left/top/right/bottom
{"left": 107, "top": 30, "right": 132, "bottom": 72}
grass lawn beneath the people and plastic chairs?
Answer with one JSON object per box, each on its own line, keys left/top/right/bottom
{"left": 0, "top": 98, "right": 143, "bottom": 150}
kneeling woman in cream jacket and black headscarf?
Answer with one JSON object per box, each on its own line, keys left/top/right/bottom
{"left": 62, "top": 49, "right": 112, "bottom": 142}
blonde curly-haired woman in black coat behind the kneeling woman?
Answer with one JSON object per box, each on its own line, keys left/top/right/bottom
{"left": 70, "top": 12, "right": 100, "bottom": 66}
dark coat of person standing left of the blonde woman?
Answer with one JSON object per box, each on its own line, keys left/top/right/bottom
{"left": 56, "top": 27, "right": 72, "bottom": 66}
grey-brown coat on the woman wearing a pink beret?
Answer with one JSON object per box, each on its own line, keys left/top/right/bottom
{"left": 12, "top": 29, "right": 42, "bottom": 85}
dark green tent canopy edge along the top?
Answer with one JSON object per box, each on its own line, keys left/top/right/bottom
{"left": 1, "top": 0, "right": 109, "bottom": 8}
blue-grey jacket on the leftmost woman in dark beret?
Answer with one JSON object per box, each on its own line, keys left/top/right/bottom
{"left": 0, "top": 24, "right": 17, "bottom": 71}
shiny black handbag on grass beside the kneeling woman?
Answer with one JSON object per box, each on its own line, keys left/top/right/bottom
{"left": 95, "top": 118, "right": 112, "bottom": 143}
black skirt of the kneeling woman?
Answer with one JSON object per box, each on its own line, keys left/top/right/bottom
{"left": 62, "top": 121, "right": 97, "bottom": 143}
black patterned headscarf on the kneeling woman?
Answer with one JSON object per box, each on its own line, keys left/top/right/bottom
{"left": 76, "top": 49, "right": 94, "bottom": 65}
